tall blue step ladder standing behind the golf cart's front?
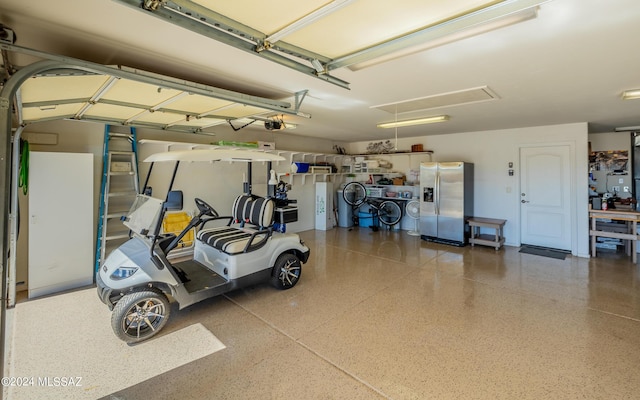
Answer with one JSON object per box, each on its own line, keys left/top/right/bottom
{"left": 95, "top": 125, "right": 140, "bottom": 271}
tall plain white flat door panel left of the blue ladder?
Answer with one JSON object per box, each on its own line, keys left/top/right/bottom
{"left": 29, "top": 152, "right": 95, "bottom": 298}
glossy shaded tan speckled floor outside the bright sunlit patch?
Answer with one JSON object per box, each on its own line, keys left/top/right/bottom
{"left": 12, "top": 228, "right": 640, "bottom": 399}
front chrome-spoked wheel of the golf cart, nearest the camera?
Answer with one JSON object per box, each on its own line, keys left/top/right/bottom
{"left": 111, "top": 290, "right": 170, "bottom": 343}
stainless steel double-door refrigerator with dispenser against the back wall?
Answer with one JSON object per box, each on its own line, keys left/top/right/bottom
{"left": 420, "top": 162, "right": 473, "bottom": 246}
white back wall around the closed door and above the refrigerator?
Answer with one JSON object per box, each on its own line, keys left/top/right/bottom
{"left": 348, "top": 123, "right": 589, "bottom": 257}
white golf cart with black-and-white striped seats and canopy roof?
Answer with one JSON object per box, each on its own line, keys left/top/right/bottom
{"left": 96, "top": 149, "right": 309, "bottom": 343}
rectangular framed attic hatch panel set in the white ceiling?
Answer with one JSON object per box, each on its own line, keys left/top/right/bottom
{"left": 371, "top": 86, "right": 499, "bottom": 114}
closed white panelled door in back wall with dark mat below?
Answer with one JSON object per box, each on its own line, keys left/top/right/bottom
{"left": 520, "top": 146, "right": 572, "bottom": 250}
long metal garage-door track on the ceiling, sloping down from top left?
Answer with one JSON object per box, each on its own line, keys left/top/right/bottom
{"left": 110, "top": 0, "right": 349, "bottom": 89}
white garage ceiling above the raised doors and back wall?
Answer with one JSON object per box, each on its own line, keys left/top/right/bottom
{"left": 0, "top": 0, "right": 640, "bottom": 141}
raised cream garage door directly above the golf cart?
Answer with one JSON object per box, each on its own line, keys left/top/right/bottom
{"left": 19, "top": 70, "right": 286, "bottom": 132}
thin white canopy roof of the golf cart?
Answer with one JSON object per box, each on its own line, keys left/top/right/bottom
{"left": 144, "top": 149, "right": 285, "bottom": 162}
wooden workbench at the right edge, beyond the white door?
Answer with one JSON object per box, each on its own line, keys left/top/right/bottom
{"left": 589, "top": 210, "right": 640, "bottom": 264}
